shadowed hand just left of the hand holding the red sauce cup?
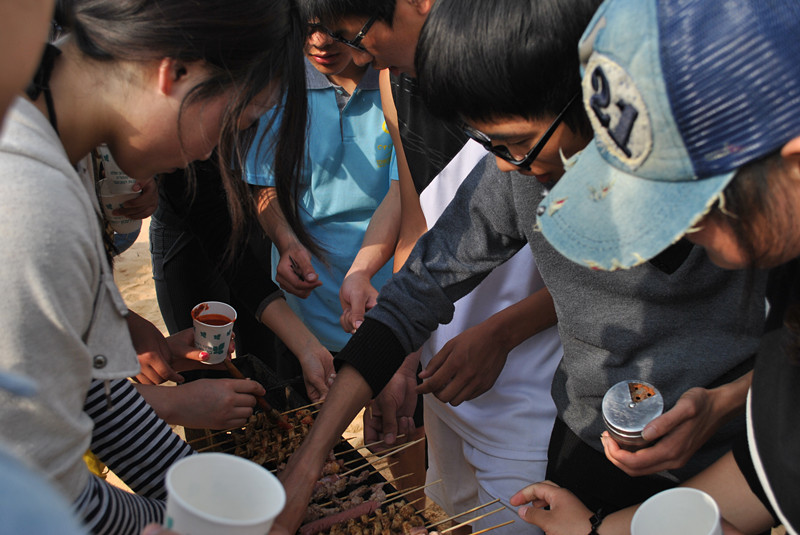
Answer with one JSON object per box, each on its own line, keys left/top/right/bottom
{"left": 127, "top": 311, "right": 183, "bottom": 385}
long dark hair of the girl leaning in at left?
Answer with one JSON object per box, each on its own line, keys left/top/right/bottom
{"left": 55, "top": 0, "right": 309, "bottom": 254}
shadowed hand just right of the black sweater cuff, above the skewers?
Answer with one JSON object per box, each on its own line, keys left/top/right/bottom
{"left": 364, "top": 366, "right": 417, "bottom": 452}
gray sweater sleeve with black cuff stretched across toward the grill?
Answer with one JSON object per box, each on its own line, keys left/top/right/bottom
{"left": 337, "top": 157, "right": 527, "bottom": 392}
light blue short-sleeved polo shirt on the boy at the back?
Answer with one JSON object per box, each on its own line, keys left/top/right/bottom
{"left": 245, "top": 62, "right": 394, "bottom": 351}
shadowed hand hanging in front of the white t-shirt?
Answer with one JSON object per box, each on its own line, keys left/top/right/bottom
{"left": 417, "top": 322, "right": 508, "bottom": 407}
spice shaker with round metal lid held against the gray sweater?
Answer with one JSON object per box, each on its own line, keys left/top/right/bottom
{"left": 603, "top": 381, "right": 664, "bottom": 451}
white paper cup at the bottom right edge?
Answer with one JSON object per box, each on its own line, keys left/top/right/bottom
{"left": 631, "top": 487, "right": 722, "bottom": 535}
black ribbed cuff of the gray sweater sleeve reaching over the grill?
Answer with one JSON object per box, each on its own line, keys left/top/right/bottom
{"left": 334, "top": 318, "right": 406, "bottom": 397}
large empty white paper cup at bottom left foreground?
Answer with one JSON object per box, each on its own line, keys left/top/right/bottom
{"left": 164, "top": 453, "right": 286, "bottom": 535}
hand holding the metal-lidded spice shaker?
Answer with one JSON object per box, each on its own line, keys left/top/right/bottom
{"left": 601, "top": 388, "right": 723, "bottom": 477}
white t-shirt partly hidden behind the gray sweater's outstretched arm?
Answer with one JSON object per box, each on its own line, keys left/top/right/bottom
{"left": 420, "top": 141, "right": 563, "bottom": 460}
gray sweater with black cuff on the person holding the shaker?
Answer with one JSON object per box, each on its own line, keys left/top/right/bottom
{"left": 337, "top": 153, "right": 765, "bottom": 477}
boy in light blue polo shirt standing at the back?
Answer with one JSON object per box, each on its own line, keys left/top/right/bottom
{"left": 246, "top": 24, "right": 396, "bottom": 375}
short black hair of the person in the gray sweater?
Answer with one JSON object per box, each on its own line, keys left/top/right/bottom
{"left": 415, "top": 0, "right": 601, "bottom": 135}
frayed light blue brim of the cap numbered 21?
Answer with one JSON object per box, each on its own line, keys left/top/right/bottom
{"left": 538, "top": 141, "right": 734, "bottom": 271}
